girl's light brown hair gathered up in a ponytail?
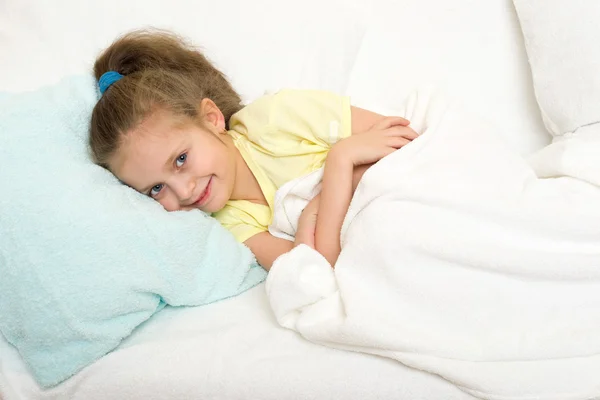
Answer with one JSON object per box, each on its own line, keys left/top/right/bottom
{"left": 89, "top": 30, "right": 242, "bottom": 168}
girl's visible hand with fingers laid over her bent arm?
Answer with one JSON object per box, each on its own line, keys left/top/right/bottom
{"left": 331, "top": 117, "right": 419, "bottom": 167}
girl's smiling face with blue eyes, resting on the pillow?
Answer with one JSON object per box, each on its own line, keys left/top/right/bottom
{"left": 109, "top": 106, "right": 235, "bottom": 213}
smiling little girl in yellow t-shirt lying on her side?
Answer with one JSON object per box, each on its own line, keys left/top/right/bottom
{"left": 90, "top": 31, "right": 417, "bottom": 270}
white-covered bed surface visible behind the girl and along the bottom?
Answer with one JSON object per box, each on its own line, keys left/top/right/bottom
{"left": 0, "top": 0, "right": 564, "bottom": 400}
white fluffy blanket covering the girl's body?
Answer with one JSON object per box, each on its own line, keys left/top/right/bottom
{"left": 266, "top": 92, "right": 600, "bottom": 400}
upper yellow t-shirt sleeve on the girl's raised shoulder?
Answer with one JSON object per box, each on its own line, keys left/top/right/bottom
{"left": 230, "top": 89, "right": 352, "bottom": 156}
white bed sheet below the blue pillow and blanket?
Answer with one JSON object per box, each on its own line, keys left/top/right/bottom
{"left": 0, "top": 284, "right": 472, "bottom": 400}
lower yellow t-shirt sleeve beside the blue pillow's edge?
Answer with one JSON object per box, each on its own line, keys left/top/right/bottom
{"left": 213, "top": 200, "right": 270, "bottom": 243}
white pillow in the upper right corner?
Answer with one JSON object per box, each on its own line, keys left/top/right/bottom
{"left": 513, "top": 0, "right": 600, "bottom": 136}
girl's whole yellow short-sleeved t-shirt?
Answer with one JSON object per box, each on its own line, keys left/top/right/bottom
{"left": 213, "top": 90, "right": 351, "bottom": 242}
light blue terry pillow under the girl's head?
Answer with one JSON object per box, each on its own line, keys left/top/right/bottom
{"left": 0, "top": 76, "right": 266, "bottom": 387}
